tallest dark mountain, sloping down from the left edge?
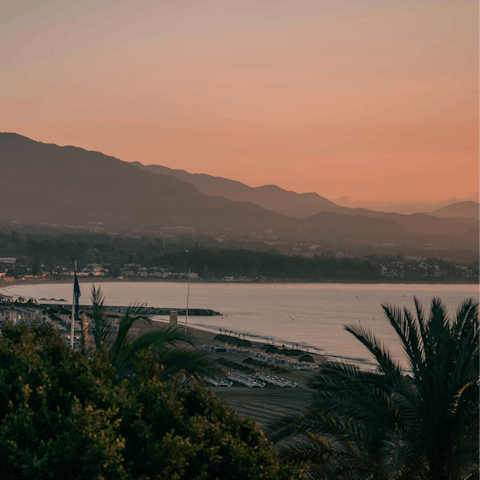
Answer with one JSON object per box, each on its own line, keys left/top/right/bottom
{"left": 0, "top": 133, "right": 295, "bottom": 233}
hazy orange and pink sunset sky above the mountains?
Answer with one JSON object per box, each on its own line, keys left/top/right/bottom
{"left": 0, "top": 0, "right": 479, "bottom": 201}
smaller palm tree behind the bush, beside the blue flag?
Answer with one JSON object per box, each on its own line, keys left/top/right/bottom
{"left": 91, "top": 286, "right": 214, "bottom": 378}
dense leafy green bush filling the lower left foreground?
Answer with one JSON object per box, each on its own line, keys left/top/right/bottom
{"left": 0, "top": 326, "right": 300, "bottom": 480}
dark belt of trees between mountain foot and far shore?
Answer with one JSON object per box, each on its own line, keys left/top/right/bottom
{"left": 0, "top": 231, "right": 478, "bottom": 281}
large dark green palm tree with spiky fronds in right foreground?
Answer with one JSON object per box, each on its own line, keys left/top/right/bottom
{"left": 268, "top": 298, "right": 480, "bottom": 480}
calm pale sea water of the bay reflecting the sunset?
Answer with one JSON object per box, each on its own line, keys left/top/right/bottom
{"left": 0, "top": 282, "right": 479, "bottom": 362}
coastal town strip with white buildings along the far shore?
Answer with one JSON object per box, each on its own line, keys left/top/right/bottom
{"left": 0, "top": 251, "right": 478, "bottom": 284}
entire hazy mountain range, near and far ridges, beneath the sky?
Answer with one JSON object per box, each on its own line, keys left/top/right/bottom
{"left": 0, "top": 133, "right": 478, "bottom": 249}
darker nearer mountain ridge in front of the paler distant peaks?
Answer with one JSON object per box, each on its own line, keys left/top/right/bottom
{"left": 0, "top": 133, "right": 478, "bottom": 249}
